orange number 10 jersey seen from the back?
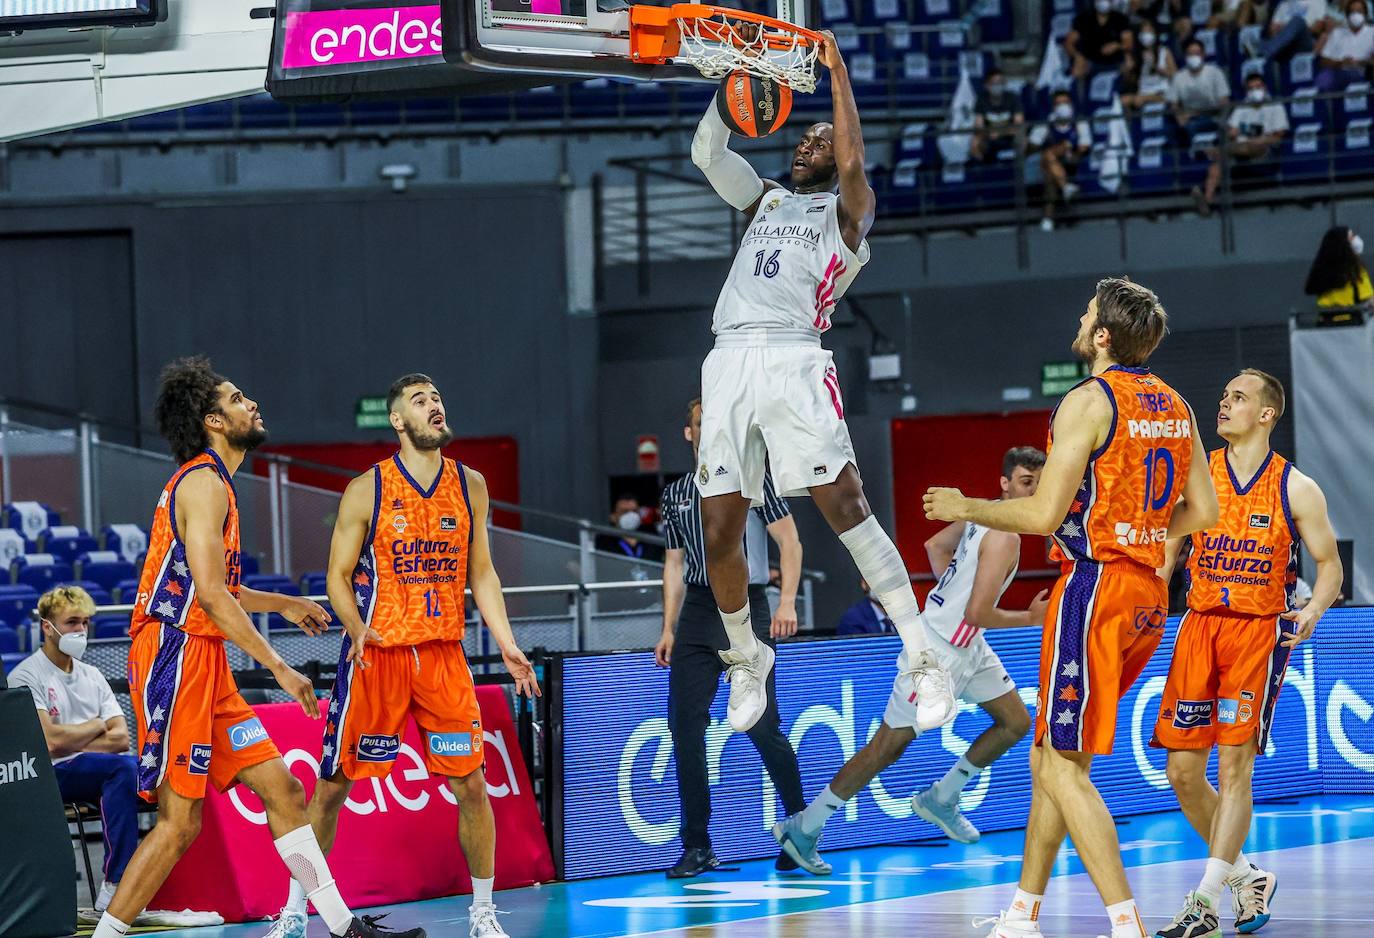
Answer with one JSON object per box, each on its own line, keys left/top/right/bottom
{"left": 1048, "top": 365, "right": 1193, "bottom": 567}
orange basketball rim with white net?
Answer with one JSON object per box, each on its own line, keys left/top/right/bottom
{"left": 629, "top": 3, "right": 824, "bottom": 93}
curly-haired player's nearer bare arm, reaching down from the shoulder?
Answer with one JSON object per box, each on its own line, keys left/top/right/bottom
{"left": 176, "top": 472, "right": 320, "bottom": 718}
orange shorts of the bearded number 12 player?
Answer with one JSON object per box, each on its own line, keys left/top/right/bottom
{"left": 320, "top": 637, "right": 482, "bottom": 780}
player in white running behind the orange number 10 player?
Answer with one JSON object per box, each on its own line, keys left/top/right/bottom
{"left": 774, "top": 446, "right": 1046, "bottom": 872}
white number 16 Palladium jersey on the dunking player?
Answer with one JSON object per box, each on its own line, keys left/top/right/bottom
{"left": 710, "top": 188, "right": 868, "bottom": 335}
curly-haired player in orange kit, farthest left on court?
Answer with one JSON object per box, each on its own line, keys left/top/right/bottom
{"left": 93, "top": 358, "right": 425, "bottom": 938}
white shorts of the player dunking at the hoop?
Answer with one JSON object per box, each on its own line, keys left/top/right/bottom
{"left": 695, "top": 331, "right": 855, "bottom": 505}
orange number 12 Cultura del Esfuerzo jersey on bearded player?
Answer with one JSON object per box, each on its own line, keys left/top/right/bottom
{"left": 353, "top": 453, "right": 473, "bottom": 645}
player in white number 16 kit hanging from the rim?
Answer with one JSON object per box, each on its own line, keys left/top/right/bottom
{"left": 691, "top": 36, "right": 955, "bottom": 732}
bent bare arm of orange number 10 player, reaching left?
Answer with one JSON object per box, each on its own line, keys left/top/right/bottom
{"left": 925, "top": 382, "right": 1112, "bottom": 536}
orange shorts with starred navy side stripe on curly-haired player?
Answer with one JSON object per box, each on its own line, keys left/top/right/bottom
{"left": 129, "top": 624, "right": 282, "bottom": 801}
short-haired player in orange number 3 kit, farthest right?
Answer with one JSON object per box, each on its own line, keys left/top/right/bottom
{"left": 1151, "top": 368, "right": 1342, "bottom": 938}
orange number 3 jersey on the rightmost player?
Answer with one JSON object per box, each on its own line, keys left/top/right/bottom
{"left": 1187, "top": 448, "right": 1300, "bottom": 615}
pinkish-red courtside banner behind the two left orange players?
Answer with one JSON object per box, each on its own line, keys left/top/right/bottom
{"left": 148, "top": 685, "right": 554, "bottom": 922}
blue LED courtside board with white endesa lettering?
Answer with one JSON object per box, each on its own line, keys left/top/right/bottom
{"left": 561, "top": 608, "right": 1374, "bottom": 879}
